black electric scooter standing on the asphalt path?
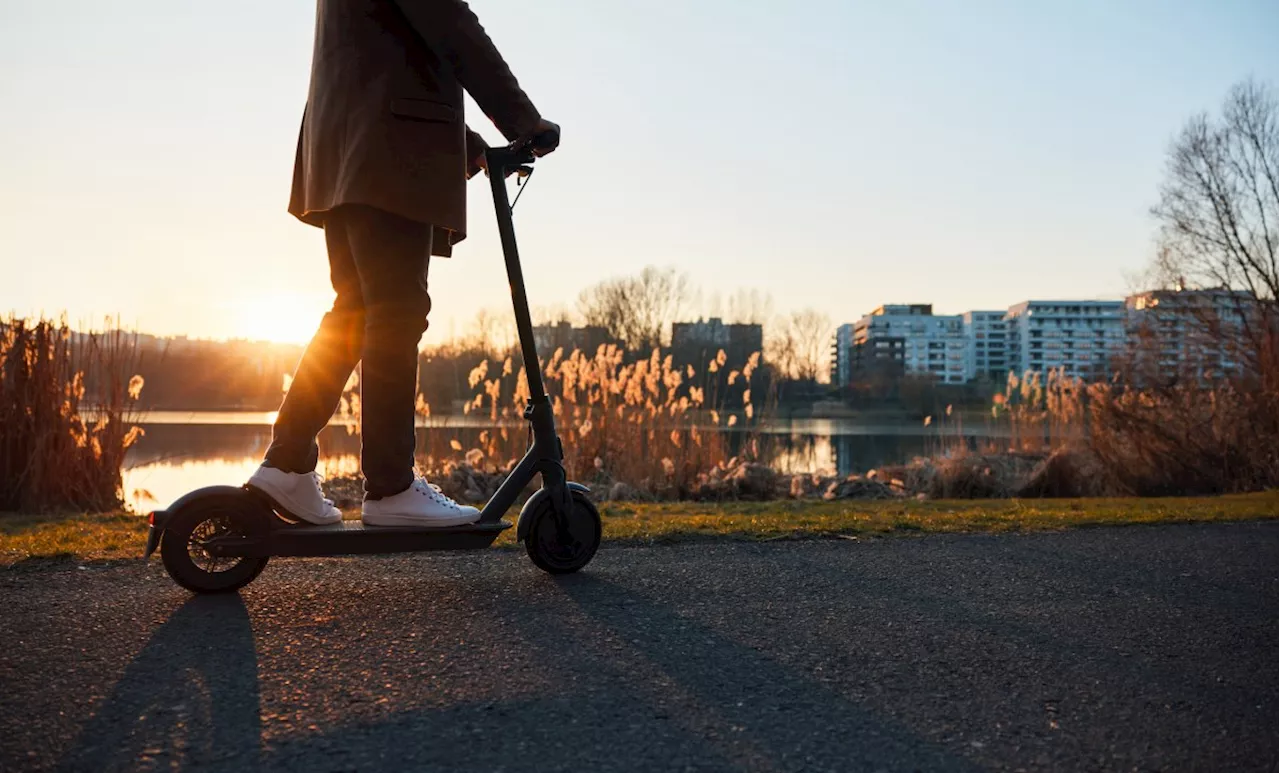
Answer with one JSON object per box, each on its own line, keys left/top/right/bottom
{"left": 146, "top": 138, "right": 600, "bottom": 593}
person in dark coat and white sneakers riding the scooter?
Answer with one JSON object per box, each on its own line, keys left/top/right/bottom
{"left": 248, "top": 0, "right": 559, "bottom": 526}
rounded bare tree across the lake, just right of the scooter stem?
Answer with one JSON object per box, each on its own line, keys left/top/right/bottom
{"left": 577, "top": 266, "right": 692, "bottom": 349}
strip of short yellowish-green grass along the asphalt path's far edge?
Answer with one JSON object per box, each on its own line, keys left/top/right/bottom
{"left": 0, "top": 491, "right": 1280, "bottom": 564}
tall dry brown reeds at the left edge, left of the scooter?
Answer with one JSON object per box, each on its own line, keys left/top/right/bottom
{"left": 0, "top": 317, "right": 142, "bottom": 512}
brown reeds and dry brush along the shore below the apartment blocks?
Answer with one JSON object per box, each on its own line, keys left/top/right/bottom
{"left": 914, "top": 342, "right": 1280, "bottom": 497}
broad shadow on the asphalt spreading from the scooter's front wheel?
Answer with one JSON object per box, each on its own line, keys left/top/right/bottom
{"left": 254, "top": 565, "right": 975, "bottom": 770}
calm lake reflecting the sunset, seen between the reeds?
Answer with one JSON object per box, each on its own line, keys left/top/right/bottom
{"left": 124, "top": 411, "right": 993, "bottom": 512}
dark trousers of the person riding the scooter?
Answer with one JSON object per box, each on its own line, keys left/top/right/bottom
{"left": 265, "top": 205, "right": 431, "bottom": 498}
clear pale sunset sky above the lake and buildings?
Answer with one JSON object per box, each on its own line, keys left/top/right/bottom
{"left": 0, "top": 0, "right": 1280, "bottom": 343}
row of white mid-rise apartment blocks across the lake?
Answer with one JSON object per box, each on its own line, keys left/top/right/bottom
{"left": 831, "top": 289, "right": 1260, "bottom": 385}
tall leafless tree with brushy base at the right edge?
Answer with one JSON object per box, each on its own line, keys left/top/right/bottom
{"left": 1084, "top": 81, "right": 1280, "bottom": 494}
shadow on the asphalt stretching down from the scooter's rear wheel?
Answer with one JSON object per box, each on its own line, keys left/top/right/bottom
{"left": 59, "top": 595, "right": 261, "bottom": 770}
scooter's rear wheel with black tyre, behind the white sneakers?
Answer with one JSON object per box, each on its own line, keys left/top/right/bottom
{"left": 160, "top": 497, "right": 268, "bottom": 593}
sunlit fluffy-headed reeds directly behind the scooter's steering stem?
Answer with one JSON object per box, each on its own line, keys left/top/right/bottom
{"left": 417, "top": 344, "right": 765, "bottom": 498}
